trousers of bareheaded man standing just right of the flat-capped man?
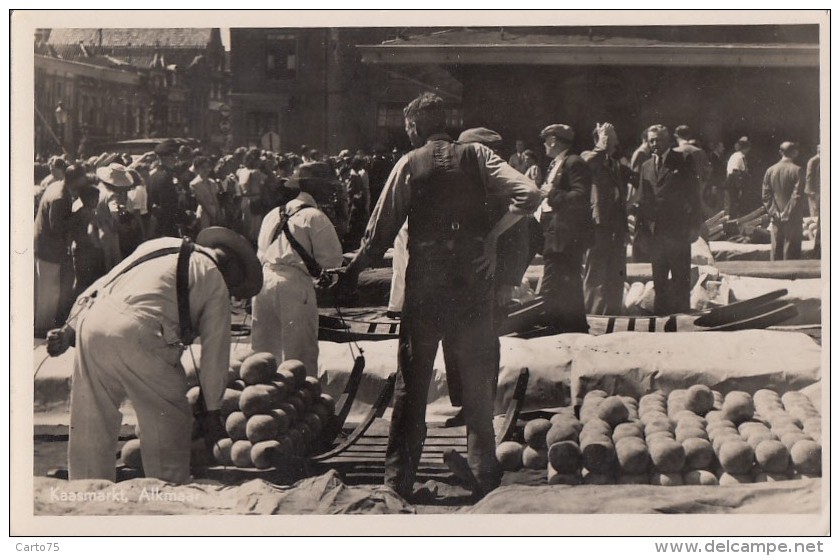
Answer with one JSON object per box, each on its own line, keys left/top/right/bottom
{"left": 583, "top": 228, "right": 627, "bottom": 315}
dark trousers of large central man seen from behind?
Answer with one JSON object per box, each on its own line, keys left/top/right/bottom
{"left": 385, "top": 250, "right": 501, "bottom": 496}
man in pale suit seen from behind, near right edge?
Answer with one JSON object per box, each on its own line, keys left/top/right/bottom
{"left": 761, "top": 141, "right": 806, "bottom": 261}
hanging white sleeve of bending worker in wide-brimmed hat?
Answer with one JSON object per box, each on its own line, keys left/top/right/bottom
{"left": 190, "top": 262, "right": 230, "bottom": 411}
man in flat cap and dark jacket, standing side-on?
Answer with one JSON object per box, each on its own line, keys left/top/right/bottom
{"left": 540, "top": 124, "right": 592, "bottom": 333}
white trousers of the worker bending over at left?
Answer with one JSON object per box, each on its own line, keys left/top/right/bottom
{"left": 69, "top": 298, "right": 192, "bottom": 483}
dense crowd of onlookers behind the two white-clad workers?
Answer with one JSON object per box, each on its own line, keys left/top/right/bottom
{"left": 35, "top": 141, "right": 402, "bottom": 335}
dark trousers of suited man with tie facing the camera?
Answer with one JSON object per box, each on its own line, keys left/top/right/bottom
{"left": 651, "top": 229, "right": 691, "bottom": 315}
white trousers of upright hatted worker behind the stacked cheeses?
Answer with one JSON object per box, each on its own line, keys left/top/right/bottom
{"left": 251, "top": 265, "right": 318, "bottom": 376}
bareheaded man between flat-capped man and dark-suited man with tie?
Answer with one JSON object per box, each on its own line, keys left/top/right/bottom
{"left": 580, "top": 123, "right": 630, "bottom": 315}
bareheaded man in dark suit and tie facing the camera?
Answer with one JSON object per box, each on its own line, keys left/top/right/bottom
{"left": 639, "top": 125, "right": 703, "bottom": 315}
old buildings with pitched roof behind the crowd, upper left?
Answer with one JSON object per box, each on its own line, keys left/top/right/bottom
{"left": 35, "top": 29, "right": 230, "bottom": 155}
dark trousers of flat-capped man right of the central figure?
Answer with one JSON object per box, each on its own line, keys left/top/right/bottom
{"left": 540, "top": 246, "right": 589, "bottom": 333}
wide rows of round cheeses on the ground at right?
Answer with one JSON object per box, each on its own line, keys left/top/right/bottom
{"left": 497, "top": 385, "right": 822, "bottom": 486}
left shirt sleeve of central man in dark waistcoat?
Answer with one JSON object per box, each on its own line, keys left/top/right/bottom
{"left": 348, "top": 156, "right": 414, "bottom": 272}
